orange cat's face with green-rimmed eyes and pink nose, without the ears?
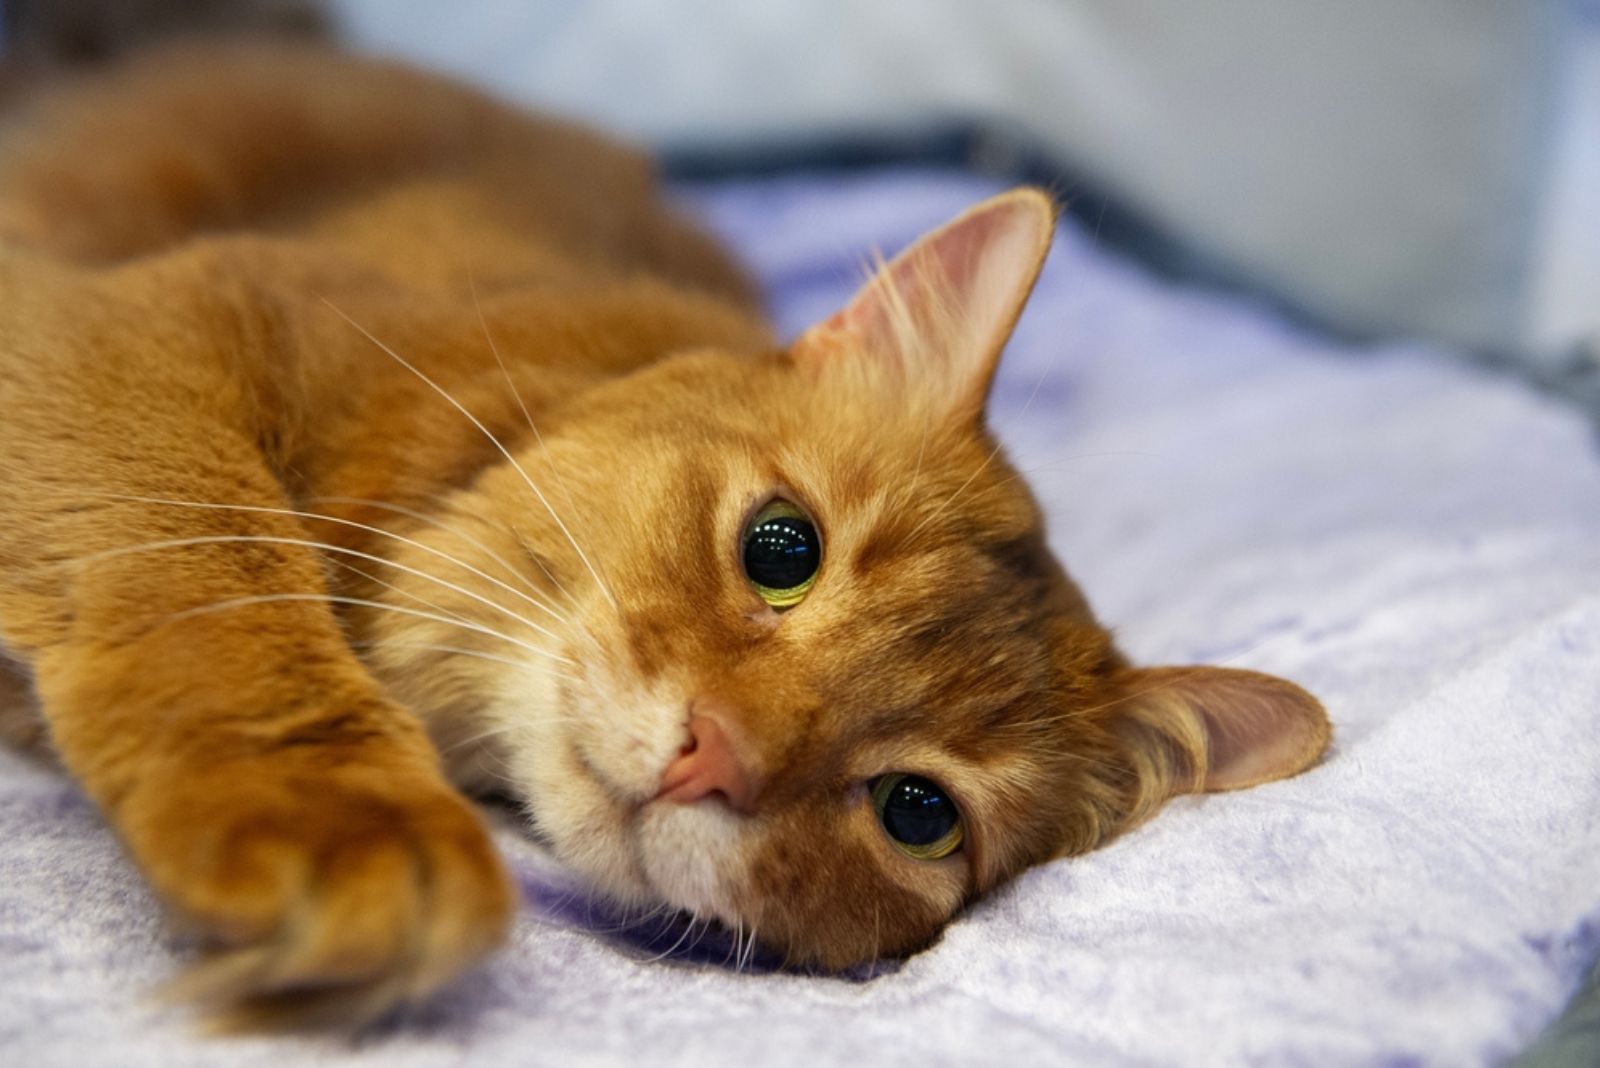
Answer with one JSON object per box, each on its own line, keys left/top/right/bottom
{"left": 486, "top": 353, "right": 1114, "bottom": 964}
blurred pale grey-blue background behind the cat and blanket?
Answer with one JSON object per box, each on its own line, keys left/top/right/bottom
{"left": 0, "top": 0, "right": 1600, "bottom": 411}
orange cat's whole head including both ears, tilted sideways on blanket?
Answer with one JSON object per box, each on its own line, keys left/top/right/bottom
{"left": 368, "top": 190, "right": 1328, "bottom": 967}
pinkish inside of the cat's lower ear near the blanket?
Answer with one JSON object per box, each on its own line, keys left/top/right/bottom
{"left": 1141, "top": 667, "right": 1331, "bottom": 790}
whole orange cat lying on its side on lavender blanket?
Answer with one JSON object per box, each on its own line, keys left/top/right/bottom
{"left": 0, "top": 45, "right": 1330, "bottom": 1026}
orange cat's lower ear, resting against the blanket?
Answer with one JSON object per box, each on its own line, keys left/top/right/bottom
{"left": 1110, "top": 667, "right": 1333, "bottom": 819}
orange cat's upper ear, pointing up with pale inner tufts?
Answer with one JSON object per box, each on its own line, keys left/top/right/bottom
{"left": 790, "top": 189, "right": 1056, "bottom": 417}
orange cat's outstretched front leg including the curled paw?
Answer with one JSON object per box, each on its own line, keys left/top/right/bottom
{"left": 0, "top": 264, "right": 514, "bottom": 1022}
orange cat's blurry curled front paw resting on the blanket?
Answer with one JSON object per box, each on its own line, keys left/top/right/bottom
{"left": 123, "top": 755, "right": 515, "bottom": 1030}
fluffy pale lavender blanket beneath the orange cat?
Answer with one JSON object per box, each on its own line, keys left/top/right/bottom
{"left": 0, "top": 173, "right": 1600, "bottom": 1066}
